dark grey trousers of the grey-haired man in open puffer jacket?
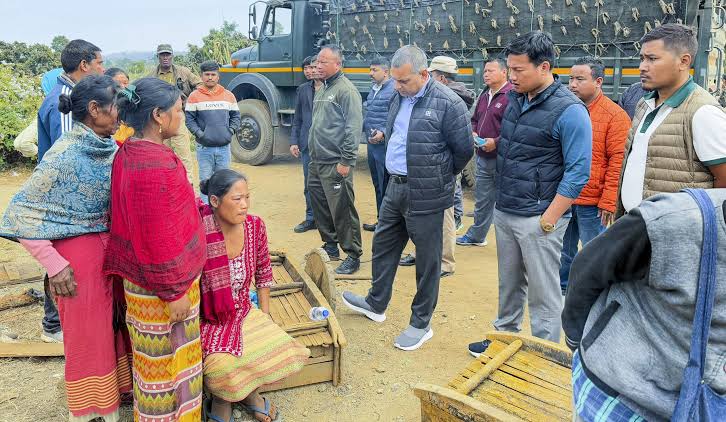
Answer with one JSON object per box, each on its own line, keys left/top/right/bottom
{"left": 366, "top": 180, "right": 444, "bottom": 328}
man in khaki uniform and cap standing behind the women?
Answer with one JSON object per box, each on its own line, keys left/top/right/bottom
{"left": 147, "top": 44, "right": 202, "bottom": 184}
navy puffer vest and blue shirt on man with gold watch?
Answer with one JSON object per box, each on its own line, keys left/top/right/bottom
{"left": 496, "top": 81, "right": 592, "bottom": 217}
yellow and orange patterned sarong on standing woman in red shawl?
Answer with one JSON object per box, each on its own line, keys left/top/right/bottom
{"left": 124, "top": 280, "right": 202, "bottom": 422}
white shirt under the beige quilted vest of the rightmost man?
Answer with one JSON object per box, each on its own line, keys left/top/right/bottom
{"left": 621, "top": 88, "right": 726, "bottom": 211}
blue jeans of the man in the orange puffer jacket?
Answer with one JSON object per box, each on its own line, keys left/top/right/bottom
{"left": 560, "top": 205, "right": 605, "bottom": 291}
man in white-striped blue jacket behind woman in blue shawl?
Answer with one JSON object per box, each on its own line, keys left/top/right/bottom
{"left": 38, "top": 40, "right": 104, "bottom": 343}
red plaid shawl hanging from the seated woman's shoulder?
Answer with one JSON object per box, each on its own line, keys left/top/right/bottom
{"left": 197, "top": 201, "right": 235, "bottom": 323}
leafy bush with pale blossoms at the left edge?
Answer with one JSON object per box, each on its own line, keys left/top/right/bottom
{"left": 0, "top": 64, "right": 43, "bottom": 166}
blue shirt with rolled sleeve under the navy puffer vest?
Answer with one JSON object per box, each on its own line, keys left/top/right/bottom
{"left": 522, "top": 95, "right": 592, "bottom": 199}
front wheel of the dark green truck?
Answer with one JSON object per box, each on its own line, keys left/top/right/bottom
{"left": 232, "top": 100, "right": 273, "bottom": 166}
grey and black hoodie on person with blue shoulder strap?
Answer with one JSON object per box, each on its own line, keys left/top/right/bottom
{"left": 562, "top": 189, "right": 726, "bottom": 421}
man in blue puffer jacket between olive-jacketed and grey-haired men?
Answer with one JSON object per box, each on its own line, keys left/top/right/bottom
{"left": 363, "top": 58, "right": 394, "bottom": 232}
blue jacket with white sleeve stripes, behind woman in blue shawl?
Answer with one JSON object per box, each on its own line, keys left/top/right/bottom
{"left": 38, "top": 74, "right": 75, "bottom": 163}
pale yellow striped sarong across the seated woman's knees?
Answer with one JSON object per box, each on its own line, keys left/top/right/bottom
{"left": 204, "top": 309, "right": 310, "bottom": 402}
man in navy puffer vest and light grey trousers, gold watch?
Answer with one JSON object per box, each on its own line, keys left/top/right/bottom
{"left": 469, "top": 31, "right": 592, "bottom": 356}
